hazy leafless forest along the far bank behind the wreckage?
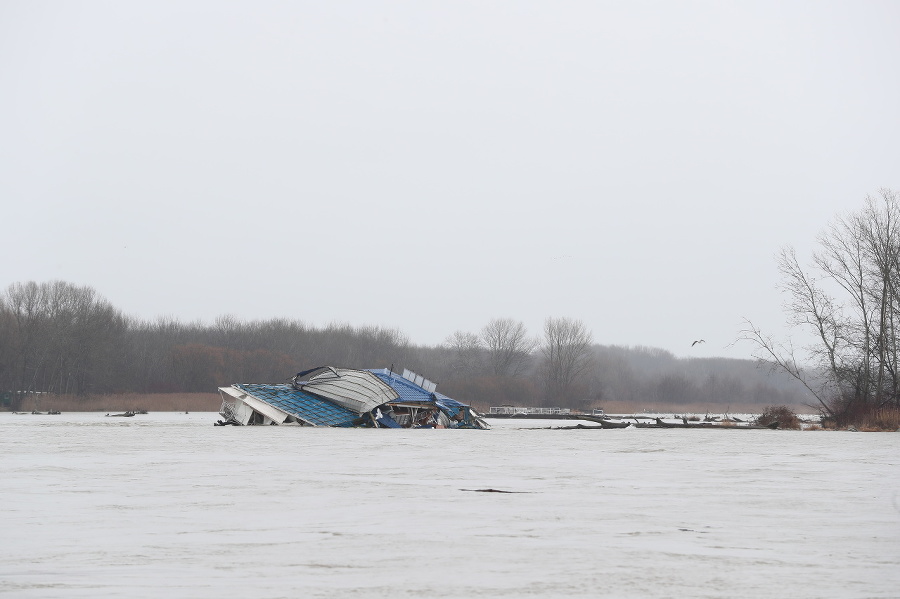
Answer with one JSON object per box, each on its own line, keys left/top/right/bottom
{"left": 0, "top": 281, "right": 810, "bottom": 410}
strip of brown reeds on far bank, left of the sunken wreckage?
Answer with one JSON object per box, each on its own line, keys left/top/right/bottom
{"left": 11, "top": 393, "right": 222, "bottom": 412}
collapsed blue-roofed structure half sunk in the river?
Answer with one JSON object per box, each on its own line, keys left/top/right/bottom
{"left": 216, "top": 366, "right": 490, "bottom": 429}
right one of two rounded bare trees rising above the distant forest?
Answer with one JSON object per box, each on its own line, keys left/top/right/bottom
{"left": 541, "top": 317, "right": 593, "bottom": 400}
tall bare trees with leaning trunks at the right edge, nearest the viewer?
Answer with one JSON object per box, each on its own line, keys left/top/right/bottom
{"left": 740, "top": 189, "right": 900, "bottom": 421}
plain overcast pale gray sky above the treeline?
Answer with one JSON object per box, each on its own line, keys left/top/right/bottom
{"left": 0, "top": 0, "right": 900, "bottom": 357}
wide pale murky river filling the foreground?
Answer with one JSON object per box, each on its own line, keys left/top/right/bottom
{"left": 0, "top": 413, "right": 900, "bottom": 599}
